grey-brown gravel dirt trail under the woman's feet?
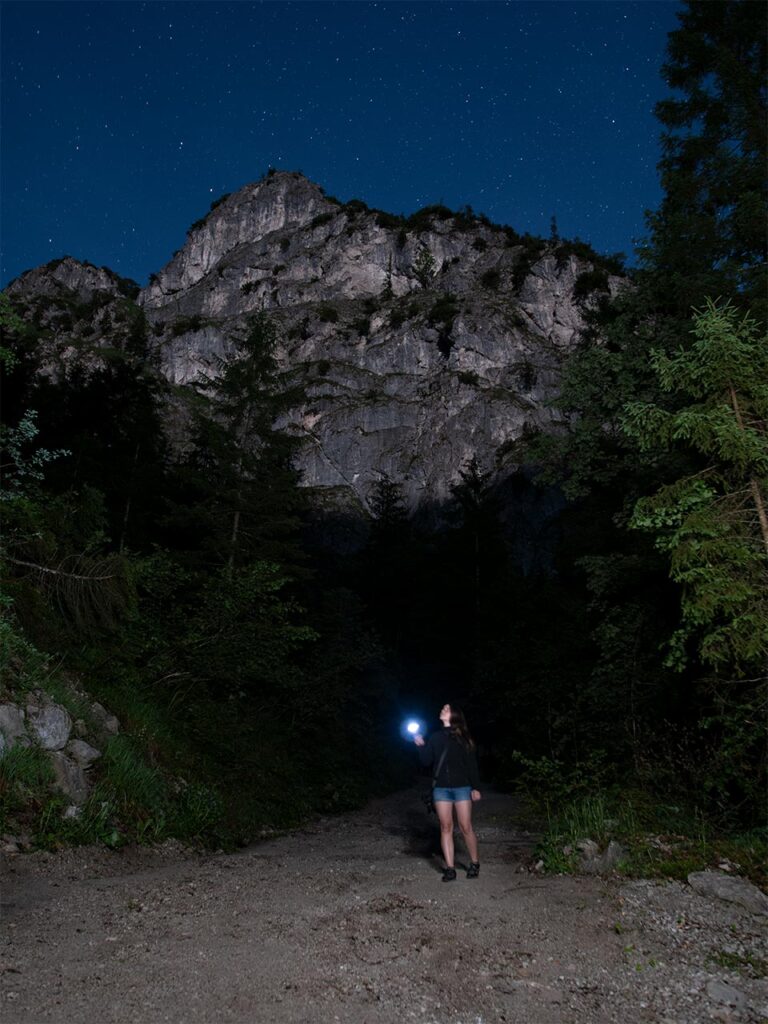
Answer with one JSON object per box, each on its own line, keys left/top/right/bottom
{"left": 0, "top": 792, "right": 768, "bottom": 1024}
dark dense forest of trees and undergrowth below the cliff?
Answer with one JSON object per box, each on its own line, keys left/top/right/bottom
{"left": 0, "top": 0, "right": 768, "bottom": 872}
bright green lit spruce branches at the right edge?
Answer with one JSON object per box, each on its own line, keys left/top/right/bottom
{"left": 625, "top": 302, "right": 768, "bottom": 674}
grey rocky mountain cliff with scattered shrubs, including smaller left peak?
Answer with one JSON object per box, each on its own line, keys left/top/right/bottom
{"left": 9, "top": 172, "right": 622, "bottom": 520}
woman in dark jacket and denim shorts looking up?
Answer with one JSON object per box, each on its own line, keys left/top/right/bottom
{"left": 414, "top": 705, "right": 480, "bottom": 882}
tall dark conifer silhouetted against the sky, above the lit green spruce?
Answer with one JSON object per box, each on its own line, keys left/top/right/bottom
{"left": 642, "top": 0, "right": 768, "bottom": 319}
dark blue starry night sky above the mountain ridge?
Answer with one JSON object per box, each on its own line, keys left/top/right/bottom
{"left": 0, "top": 0, "right": 679, "bottom": 285}
